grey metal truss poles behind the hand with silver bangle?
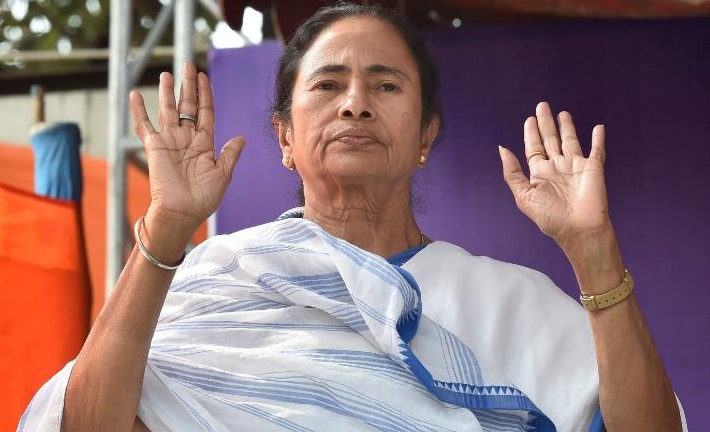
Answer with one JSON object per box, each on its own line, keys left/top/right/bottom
{"left": 106, "top": 0, "right": 221, "bottom": 297}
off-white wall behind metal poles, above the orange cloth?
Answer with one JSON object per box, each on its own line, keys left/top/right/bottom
{"left": 0, "top": 85, "right": 158, "bottom": 158}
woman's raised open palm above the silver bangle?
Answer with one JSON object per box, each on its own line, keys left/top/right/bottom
{"left": 130, "top": 63, "right": 245, "bottom": 237}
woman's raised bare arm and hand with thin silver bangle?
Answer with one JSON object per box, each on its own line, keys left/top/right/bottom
{"left": 62, "top": 65, "right": 244, "bottom": 432}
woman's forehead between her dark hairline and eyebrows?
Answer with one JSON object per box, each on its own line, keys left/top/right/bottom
{"left": 299, "top": 16, "right": 418, "bottom": 79}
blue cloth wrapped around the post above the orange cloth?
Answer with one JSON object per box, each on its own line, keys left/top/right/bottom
{"left": 30, "top": 123, "right": 82, "bottom": 201}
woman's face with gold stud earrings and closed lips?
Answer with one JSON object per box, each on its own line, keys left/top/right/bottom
{"left": 278, "top": 17, "right": 438, "bottom": 192}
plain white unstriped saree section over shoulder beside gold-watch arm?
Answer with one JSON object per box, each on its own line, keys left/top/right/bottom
{"left": 404, "top": 242, "right": 598, "bottom": 430}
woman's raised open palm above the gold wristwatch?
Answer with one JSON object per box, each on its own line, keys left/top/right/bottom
{"left": 500, "top": 102, "right": 613, "bottom": 249}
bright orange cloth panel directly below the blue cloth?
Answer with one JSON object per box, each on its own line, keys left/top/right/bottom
{"left": 0, "top": 185, "right": 91, "bottom": 431}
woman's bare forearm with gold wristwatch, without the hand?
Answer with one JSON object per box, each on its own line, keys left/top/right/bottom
{"left": 565, "top": 231, "right": 681, "bottom": 432}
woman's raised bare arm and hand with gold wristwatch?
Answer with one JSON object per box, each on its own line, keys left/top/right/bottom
{"left": 500, "top": 103, "right": 681, "bottom": 432}
